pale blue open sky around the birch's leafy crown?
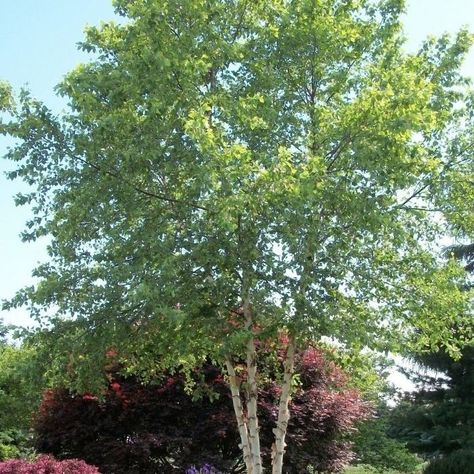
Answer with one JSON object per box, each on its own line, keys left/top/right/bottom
{"left": 0, "top": 0, "right": 474, "bottom": 325}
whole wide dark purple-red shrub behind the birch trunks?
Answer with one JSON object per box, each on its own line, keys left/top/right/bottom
{"left": 35, "top": 349, "right": 370, "bottom": 474}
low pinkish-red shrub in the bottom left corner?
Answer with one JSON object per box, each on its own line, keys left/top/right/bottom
{"left": 0, "top": 456, "right": 100, "bottom": 474}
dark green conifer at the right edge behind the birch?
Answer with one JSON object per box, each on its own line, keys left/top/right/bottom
{"left": 391, "top": 244, "right": 474, "bottom": 472}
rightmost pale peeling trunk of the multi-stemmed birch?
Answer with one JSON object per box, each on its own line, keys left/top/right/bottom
{"left": 272, "top": 338, "right": 295, "bottom": 474}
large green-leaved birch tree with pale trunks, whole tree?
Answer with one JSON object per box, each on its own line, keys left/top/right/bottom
{"left": 2, "top": 0, "right": 474, "bottom": 474}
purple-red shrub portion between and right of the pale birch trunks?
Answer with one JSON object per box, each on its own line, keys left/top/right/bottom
{"left": 259, "top": 348, "right": 371, "bottom": 474}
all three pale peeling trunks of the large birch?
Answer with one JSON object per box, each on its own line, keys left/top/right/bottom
{"left": 226, "top": 338, "right": 295, "bottom": 474}
